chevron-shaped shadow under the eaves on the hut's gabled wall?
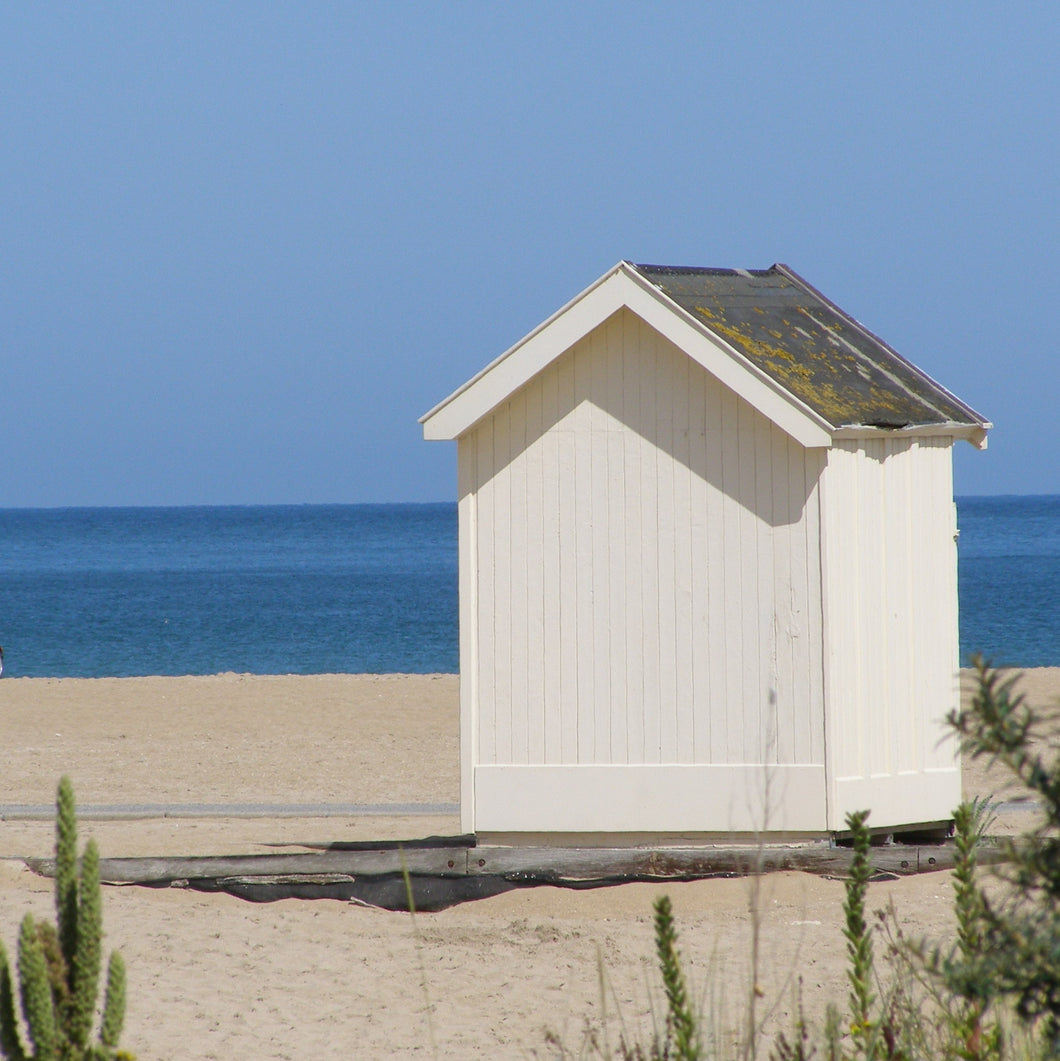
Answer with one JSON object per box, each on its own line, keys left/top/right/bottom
{"left": 469, "top": 309, "right": 827, "bottom": 528}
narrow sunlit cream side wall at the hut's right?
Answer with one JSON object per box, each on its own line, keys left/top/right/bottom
{"left": 821, "top": 437, "right": 959, "bottom": 828}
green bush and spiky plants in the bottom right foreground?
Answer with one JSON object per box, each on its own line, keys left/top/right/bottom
{"left": 550, "top": 660, "right": 1060, "bottom": 1061}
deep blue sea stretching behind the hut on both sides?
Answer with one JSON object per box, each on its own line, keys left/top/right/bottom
{"left": 0, "top": 495, "right": 1060, "bottom": 678}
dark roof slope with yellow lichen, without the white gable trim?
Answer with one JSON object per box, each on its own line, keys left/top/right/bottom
{"left": 631, "top": 265, "right": 987, "bottom": 429}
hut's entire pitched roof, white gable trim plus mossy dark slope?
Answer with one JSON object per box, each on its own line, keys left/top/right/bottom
{"left": 421, "top": 262, "right": 992, "bottom": 448}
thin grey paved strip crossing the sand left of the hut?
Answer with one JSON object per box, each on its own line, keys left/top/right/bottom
{"left": 0, "top": 803, "right": 461, "bottom": 821}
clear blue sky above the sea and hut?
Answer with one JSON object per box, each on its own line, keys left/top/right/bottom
{"left": 0, "top": 0, "right": 1060, "bottom": 506}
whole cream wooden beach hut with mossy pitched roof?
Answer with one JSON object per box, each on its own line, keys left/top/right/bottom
{"left": 421, "top": 262, "right": 991, "bottom": 843}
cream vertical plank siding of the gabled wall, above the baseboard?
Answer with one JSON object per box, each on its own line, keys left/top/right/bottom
{"left": 462, "top": 311, "right": 824, "bottom": 780}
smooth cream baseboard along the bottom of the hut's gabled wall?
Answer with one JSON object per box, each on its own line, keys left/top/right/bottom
{"left": 473, "top": 764, "right": 827, "bottom": 833}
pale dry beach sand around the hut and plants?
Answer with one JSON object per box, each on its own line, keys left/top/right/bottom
{"left": 0, "top": 668, "right": 1060, "bottom": 1061}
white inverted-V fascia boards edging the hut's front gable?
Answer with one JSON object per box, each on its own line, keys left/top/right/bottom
{"left": 420, "top": 262, "right": 833, "bottom": 448}
